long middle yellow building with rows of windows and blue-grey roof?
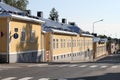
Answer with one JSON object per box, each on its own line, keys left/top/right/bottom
{"left": 43, "top": 19, "right": 93, "bottom": 62}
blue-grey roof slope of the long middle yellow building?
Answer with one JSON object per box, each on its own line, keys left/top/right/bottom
{"left": 40, "top": 18, "right": 82, "bottom": 34}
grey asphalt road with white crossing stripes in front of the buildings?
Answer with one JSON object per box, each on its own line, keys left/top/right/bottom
{"left": 0, "top": 54, "right": 120, "bottom": 80}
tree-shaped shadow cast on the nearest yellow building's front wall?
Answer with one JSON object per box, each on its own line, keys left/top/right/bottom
{"left": 16, "top": 23, "right": 41, "bottom": 62}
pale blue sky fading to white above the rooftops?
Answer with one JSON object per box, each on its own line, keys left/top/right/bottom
{"left": 27, "top": 0, "right": 120, "bottom": 38}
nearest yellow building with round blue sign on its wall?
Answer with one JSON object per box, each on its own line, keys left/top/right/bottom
{"left": 0, "top": 11, "right": 44, "bottom": 63}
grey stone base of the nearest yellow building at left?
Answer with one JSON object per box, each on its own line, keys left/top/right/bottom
{"left": 0, "top": 51, "right": 44, "bottom": 63}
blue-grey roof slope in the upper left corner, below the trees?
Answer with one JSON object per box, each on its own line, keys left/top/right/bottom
{"left": 0, "top": 2, "right": 24, "bottom": 13}
